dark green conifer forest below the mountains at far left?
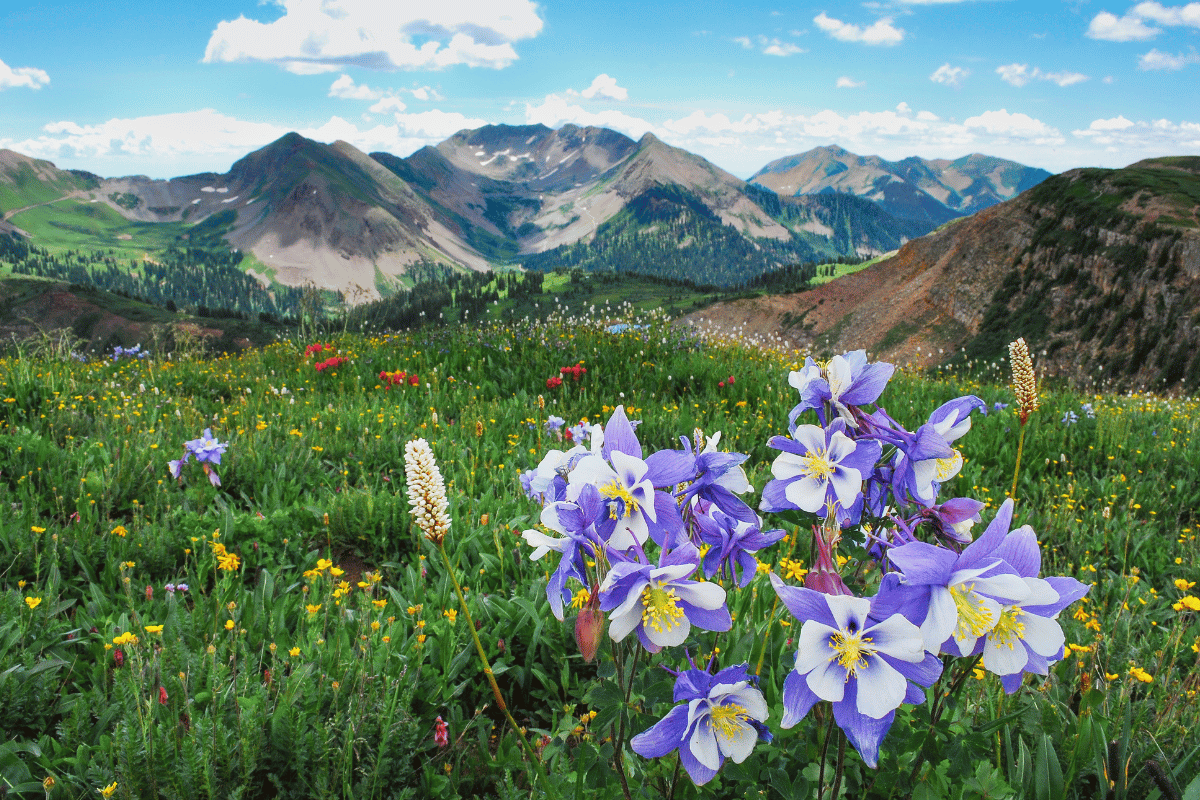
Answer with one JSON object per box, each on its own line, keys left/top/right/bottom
{"left": 0, "top": 234, "right": 304, "bottom": 317}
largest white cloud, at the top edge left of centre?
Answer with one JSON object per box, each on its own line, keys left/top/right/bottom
{"left": 204, "top": 0, "right": 542, "bottom": 74}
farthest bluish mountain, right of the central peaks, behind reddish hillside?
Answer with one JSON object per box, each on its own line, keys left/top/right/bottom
{"left": 750, "top": 145, "right": 1050, "bottom": 229}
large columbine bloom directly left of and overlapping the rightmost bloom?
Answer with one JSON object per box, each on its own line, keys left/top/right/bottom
{"left": 872, "top": 499, "right": 1030, "bottom": 656}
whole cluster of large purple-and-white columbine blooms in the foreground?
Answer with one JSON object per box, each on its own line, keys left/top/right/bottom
{"left": 521, "top": 350, "right": 1087, "bottom": 784}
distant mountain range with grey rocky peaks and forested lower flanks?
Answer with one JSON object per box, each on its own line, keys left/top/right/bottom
{"left": 0, "top": 125, "right": 1049, "bottom": 293}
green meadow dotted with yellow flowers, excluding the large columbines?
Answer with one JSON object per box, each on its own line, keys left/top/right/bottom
{"left": 0, "top": 309, "right": 1200, "bottom": 798}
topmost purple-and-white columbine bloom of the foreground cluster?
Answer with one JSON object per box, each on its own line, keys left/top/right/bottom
{"left": 787, "top": 350, "right": 895, "bottom": 428}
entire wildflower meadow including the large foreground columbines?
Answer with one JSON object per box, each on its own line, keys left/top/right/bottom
{"left": 0, "top": 317, "right": 1200, "bottom": 799}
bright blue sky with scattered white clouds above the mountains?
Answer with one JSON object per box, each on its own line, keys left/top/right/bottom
{"left": 0, "top": 0, "right": 1200, "bottom": 178}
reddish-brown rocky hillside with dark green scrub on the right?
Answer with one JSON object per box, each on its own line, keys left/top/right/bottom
{"left": 689, "top": 157, "right": 1200, "bottom": 391}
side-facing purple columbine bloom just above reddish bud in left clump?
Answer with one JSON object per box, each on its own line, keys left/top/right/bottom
{"left": 521, "top": 486, "right": 604, "bottom": 621}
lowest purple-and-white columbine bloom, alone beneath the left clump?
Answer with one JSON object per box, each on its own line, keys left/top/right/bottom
{"left": 629, "top": 663, "right": 772, "bottom": 786}
